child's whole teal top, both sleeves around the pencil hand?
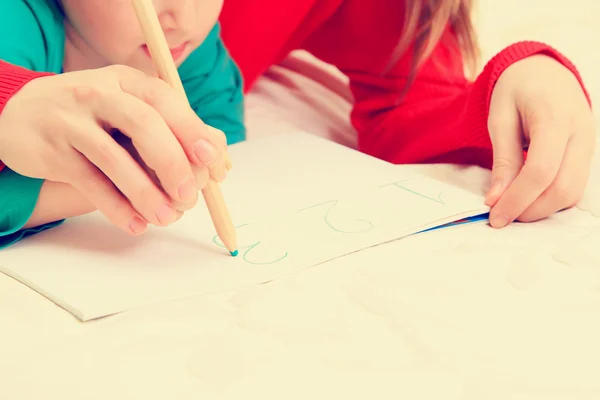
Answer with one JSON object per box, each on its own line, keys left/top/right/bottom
{"left": 0, "top": 0, "right": 246, "bottom": 249}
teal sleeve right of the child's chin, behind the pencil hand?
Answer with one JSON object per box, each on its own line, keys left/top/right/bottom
{"left": 179, "top": 23, "right": 246, "bottom": 144}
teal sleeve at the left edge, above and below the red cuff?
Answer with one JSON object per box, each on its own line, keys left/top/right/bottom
{"left": 0, "top": 0, "right": 64, "bottom": 249}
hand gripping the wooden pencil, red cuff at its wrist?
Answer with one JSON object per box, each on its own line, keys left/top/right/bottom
{"left": 0, "top": 66, "right": 226, "bottom": 234}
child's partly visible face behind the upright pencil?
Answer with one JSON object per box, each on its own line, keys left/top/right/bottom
{"left": 61, "top": 0, "right": 223, "bottom": 75}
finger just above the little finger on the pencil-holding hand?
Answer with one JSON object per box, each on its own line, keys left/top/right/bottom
{"left": 70, "top": 117, "right": 175, "bottom": 225}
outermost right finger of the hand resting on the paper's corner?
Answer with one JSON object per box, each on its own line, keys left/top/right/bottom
{"left": 518, "top": 123, "right": 595, "bottom": 222}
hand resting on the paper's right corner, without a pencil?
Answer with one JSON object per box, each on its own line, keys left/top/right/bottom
{"left": 487, "top": 55, "right": 596, "bottom": 228}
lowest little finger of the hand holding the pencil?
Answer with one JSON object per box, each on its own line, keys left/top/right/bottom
{"left": 65, "top": 151, "right": 147, "bottom": 235}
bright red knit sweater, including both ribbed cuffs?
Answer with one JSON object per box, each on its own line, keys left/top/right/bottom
{"left": 0, "top": 0, "right": 585, "bottom": 172}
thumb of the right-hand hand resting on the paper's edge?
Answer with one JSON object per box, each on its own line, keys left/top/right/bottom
{"left": 485, "top": 95, "right": 524, "bottom": 207}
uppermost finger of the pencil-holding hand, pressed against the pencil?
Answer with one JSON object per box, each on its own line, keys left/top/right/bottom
{"left": 120, "top": 70, "right": 227, "bottom": 180}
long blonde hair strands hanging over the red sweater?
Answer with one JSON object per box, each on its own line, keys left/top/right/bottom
{"left": 393, "top": 0, "right": 479, "bottom": 87}
